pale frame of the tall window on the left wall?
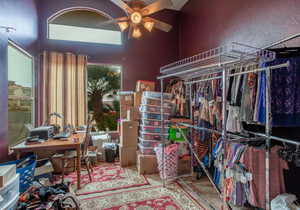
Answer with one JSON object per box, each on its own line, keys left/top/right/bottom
{"left": 7, "top": 39, "right": 36, "bottom": 148}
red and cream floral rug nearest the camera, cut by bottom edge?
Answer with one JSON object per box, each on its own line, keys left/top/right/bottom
{"left": 81, "top": 183, "right": 205, "bottom": 210}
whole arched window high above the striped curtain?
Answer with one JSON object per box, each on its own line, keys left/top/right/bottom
{"left": 48, "top": 8, "right": 122, "bottom": 45}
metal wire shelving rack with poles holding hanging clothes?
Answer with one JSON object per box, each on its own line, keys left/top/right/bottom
{"left": 158, "top": 42, "right": 300, "bottom": 210}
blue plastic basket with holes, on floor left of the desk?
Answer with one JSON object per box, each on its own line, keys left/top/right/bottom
{"left": 0, "top": 155, "right": 36, "bottom": 193}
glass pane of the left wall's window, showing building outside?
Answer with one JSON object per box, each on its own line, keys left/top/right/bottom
{"left": 8, "top": 45, "right": 33, "bottom": 145}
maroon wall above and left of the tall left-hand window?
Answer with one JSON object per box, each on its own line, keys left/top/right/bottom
{"left": 0, "top": 0, "right": 38, "bottom": 162}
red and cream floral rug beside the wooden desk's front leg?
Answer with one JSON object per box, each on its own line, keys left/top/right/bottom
{"left": 55, "top": 164, "right": 149, "bottom": 195}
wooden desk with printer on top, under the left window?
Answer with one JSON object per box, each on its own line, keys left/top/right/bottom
{"left": 11, "top": 133, "right": 85, "bottom": 189}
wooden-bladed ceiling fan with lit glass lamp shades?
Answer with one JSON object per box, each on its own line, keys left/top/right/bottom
{"left": 101, "top": 0, "right": 173, "bottom": 39}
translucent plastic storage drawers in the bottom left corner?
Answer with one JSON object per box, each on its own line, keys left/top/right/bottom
{"left": 0, "top": 174, "right": 20, "bottom": 209}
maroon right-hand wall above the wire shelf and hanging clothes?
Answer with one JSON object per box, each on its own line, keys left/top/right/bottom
{"left": 180, "top": 0, "right": 300, "bottom": 58}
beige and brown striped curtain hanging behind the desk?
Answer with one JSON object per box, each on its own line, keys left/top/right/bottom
{"left": 37, "top": 51, "right": 87, "bottom": 127}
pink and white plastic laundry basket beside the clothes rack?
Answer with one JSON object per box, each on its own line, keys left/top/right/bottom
{"left": 155, "top": 144, "right": 178, "bottom": 181}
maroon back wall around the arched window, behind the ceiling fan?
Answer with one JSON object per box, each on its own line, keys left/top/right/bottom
{"left": 37, "top": 0, "right": 178, "bottom": 90}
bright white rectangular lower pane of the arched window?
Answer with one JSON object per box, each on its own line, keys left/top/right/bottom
{"left": 49, "top": 24, "right": 122, "bottom": 45}
